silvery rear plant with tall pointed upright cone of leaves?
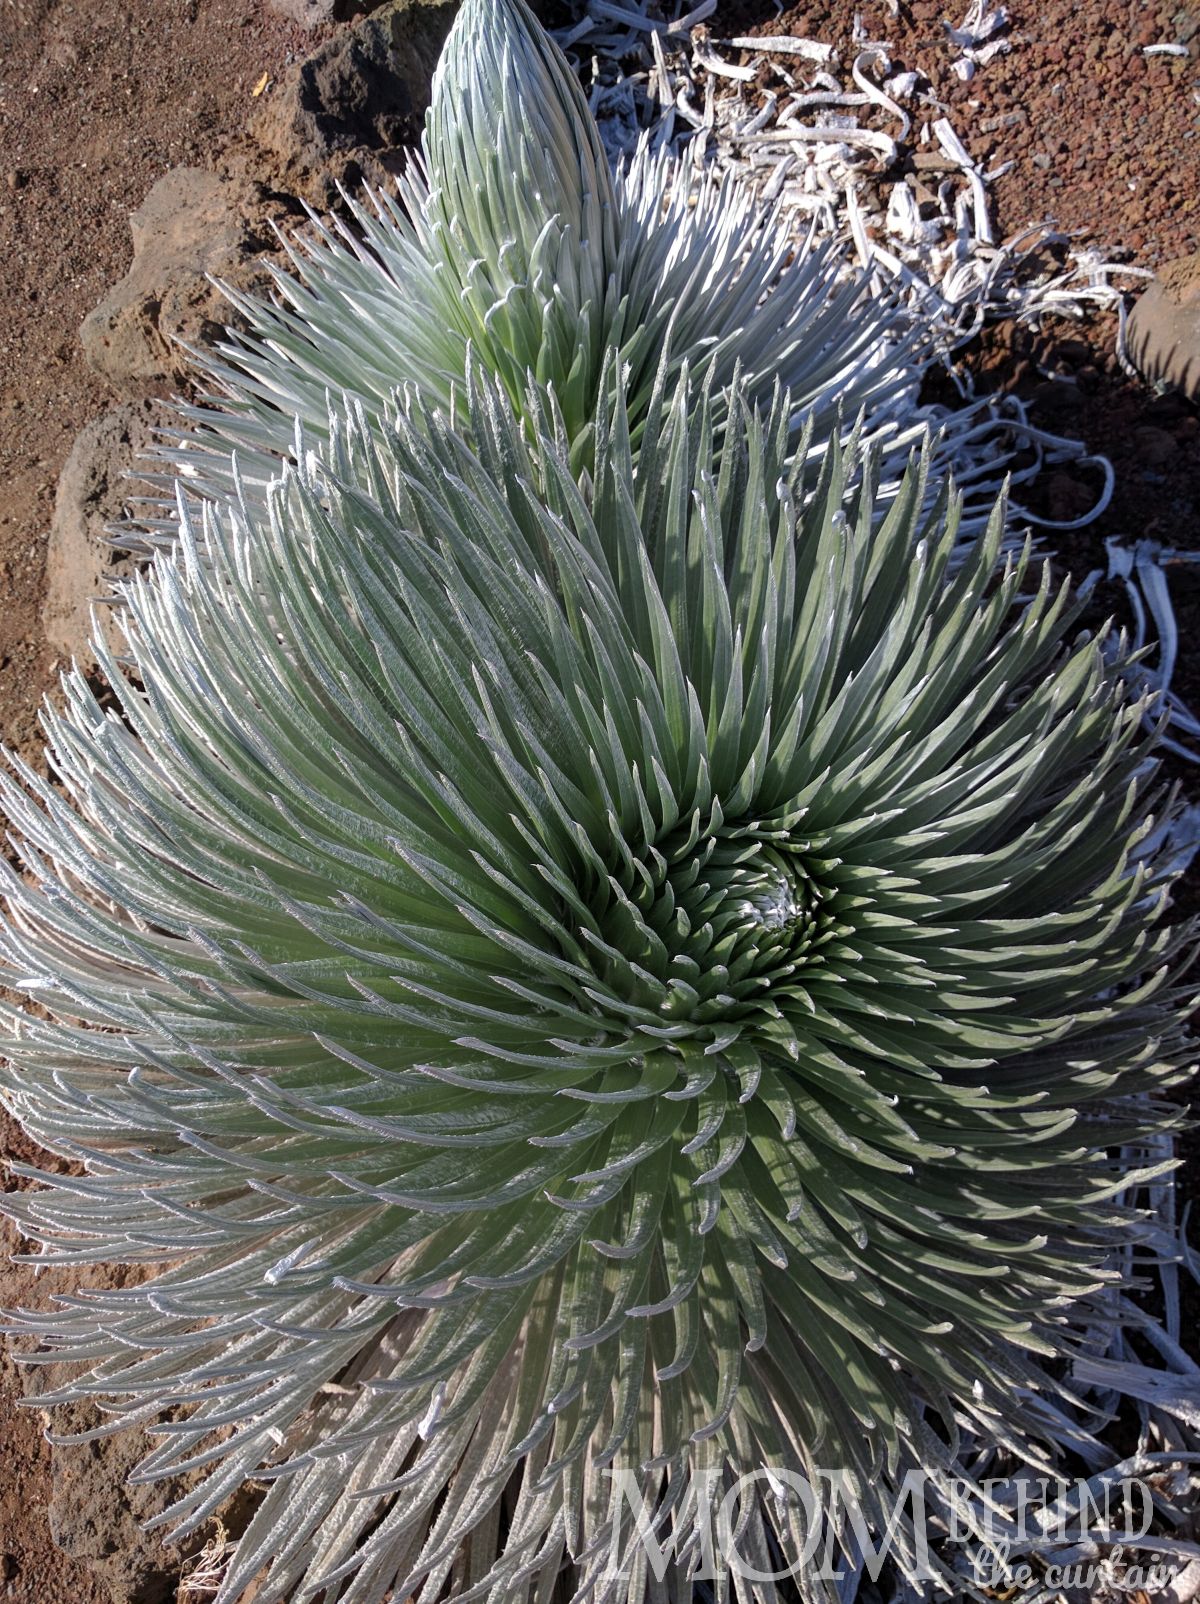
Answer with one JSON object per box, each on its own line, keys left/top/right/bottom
{"left": 162, "top": 0, "right": 979, "bottom": 519}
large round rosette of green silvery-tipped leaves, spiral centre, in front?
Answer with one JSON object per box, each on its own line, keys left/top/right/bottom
{"left": 0, "top": 374, "right": 1190, "bottom": 1604}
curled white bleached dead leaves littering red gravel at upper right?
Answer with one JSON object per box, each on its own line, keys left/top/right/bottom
{"left": 561, "top": 0, "right": 1141, "bottom": 529}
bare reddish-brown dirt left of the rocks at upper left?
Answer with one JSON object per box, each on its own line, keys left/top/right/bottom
{"left": 0, "top": 0, "right": 328, "bottom": 769}
